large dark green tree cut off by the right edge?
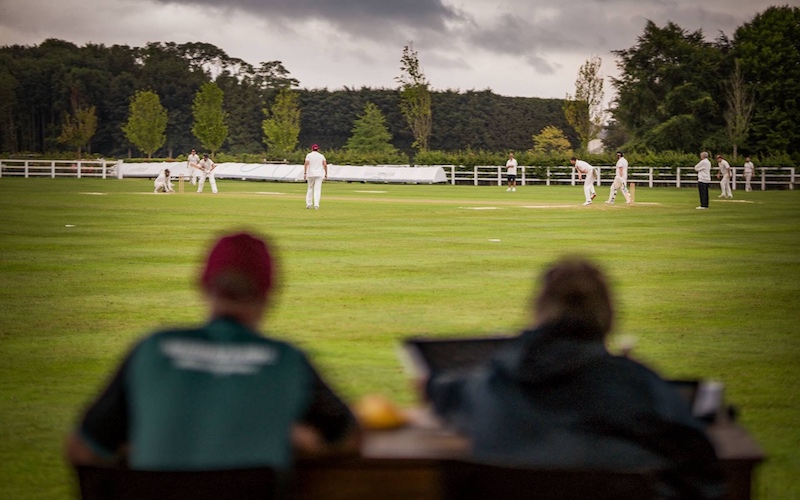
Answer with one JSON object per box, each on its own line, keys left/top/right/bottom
{"left": 733, "top": 6, "right": 800, "bottom": 154}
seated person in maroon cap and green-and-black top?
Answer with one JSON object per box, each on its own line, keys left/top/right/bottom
{"left": 66, "top": 233, "right": 358, "bottom": 470}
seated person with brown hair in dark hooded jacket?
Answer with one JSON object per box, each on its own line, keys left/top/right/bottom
{"left": 424, "top": 260, "right": 724, "bottom": 498}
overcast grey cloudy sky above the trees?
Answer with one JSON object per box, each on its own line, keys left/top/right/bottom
{"left": 0, "top": 0, "right": 800, "bottom": 100}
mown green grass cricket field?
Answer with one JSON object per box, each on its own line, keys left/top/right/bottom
{"left": 0, "top": 178, "right": 800, "bottom": 499}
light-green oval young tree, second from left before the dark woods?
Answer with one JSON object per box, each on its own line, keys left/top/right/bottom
{"left": 122, "top": 90, "right": 167, "bottom": 158}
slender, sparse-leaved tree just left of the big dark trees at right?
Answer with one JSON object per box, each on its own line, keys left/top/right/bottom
{"left": 563, "top": 57, "right": 606, "bottom": 151}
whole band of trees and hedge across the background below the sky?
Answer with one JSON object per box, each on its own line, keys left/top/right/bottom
{"left": 0, "top": 7, "right": 800, "bottom": 159}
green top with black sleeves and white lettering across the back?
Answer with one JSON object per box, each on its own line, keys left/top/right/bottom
{"left": 79, "top": 319, "right": 355, "bottom": 470}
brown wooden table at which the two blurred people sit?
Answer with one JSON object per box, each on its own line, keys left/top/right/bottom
{"left": 294, "top": 412, "right": 764, "bottom": 500}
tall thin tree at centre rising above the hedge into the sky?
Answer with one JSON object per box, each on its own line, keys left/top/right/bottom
{"left": 395, "top": 43, "right": 433, "bottom": 151}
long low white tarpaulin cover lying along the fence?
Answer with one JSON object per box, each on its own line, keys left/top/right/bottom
{"left": 118, "top": 161, "right": 447, "bottom": 184}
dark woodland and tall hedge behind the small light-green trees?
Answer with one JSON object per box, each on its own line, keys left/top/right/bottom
{"left": 0, "top": 39, "right": 577, "bottom": 157}
